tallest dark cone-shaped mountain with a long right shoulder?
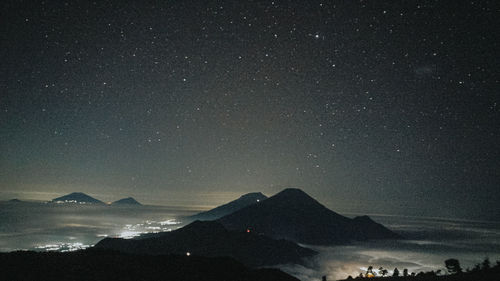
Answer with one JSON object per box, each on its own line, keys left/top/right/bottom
{"left": 218, "top": 188, "right": 401, "bottom": 245}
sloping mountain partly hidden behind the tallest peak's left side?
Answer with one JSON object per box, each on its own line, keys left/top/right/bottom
{"left": 188, "top": 192, "right": 267, "bottom": 221}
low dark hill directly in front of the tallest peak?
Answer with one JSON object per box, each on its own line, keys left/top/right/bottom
{"left": 95, "top": 221, "right": 316, "bottom": 266}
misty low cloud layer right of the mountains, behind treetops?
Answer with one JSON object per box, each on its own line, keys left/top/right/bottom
{"left": 280, "top": 217, "right": 500, "bottom": 281}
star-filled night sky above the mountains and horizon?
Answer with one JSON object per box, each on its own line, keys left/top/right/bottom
{"left": 0, "top": 0, "right": 500, "bottom": 219}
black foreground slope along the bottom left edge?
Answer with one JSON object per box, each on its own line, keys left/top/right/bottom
{"left": 0, "top": 250, "right": 298, "bottom": 281}
